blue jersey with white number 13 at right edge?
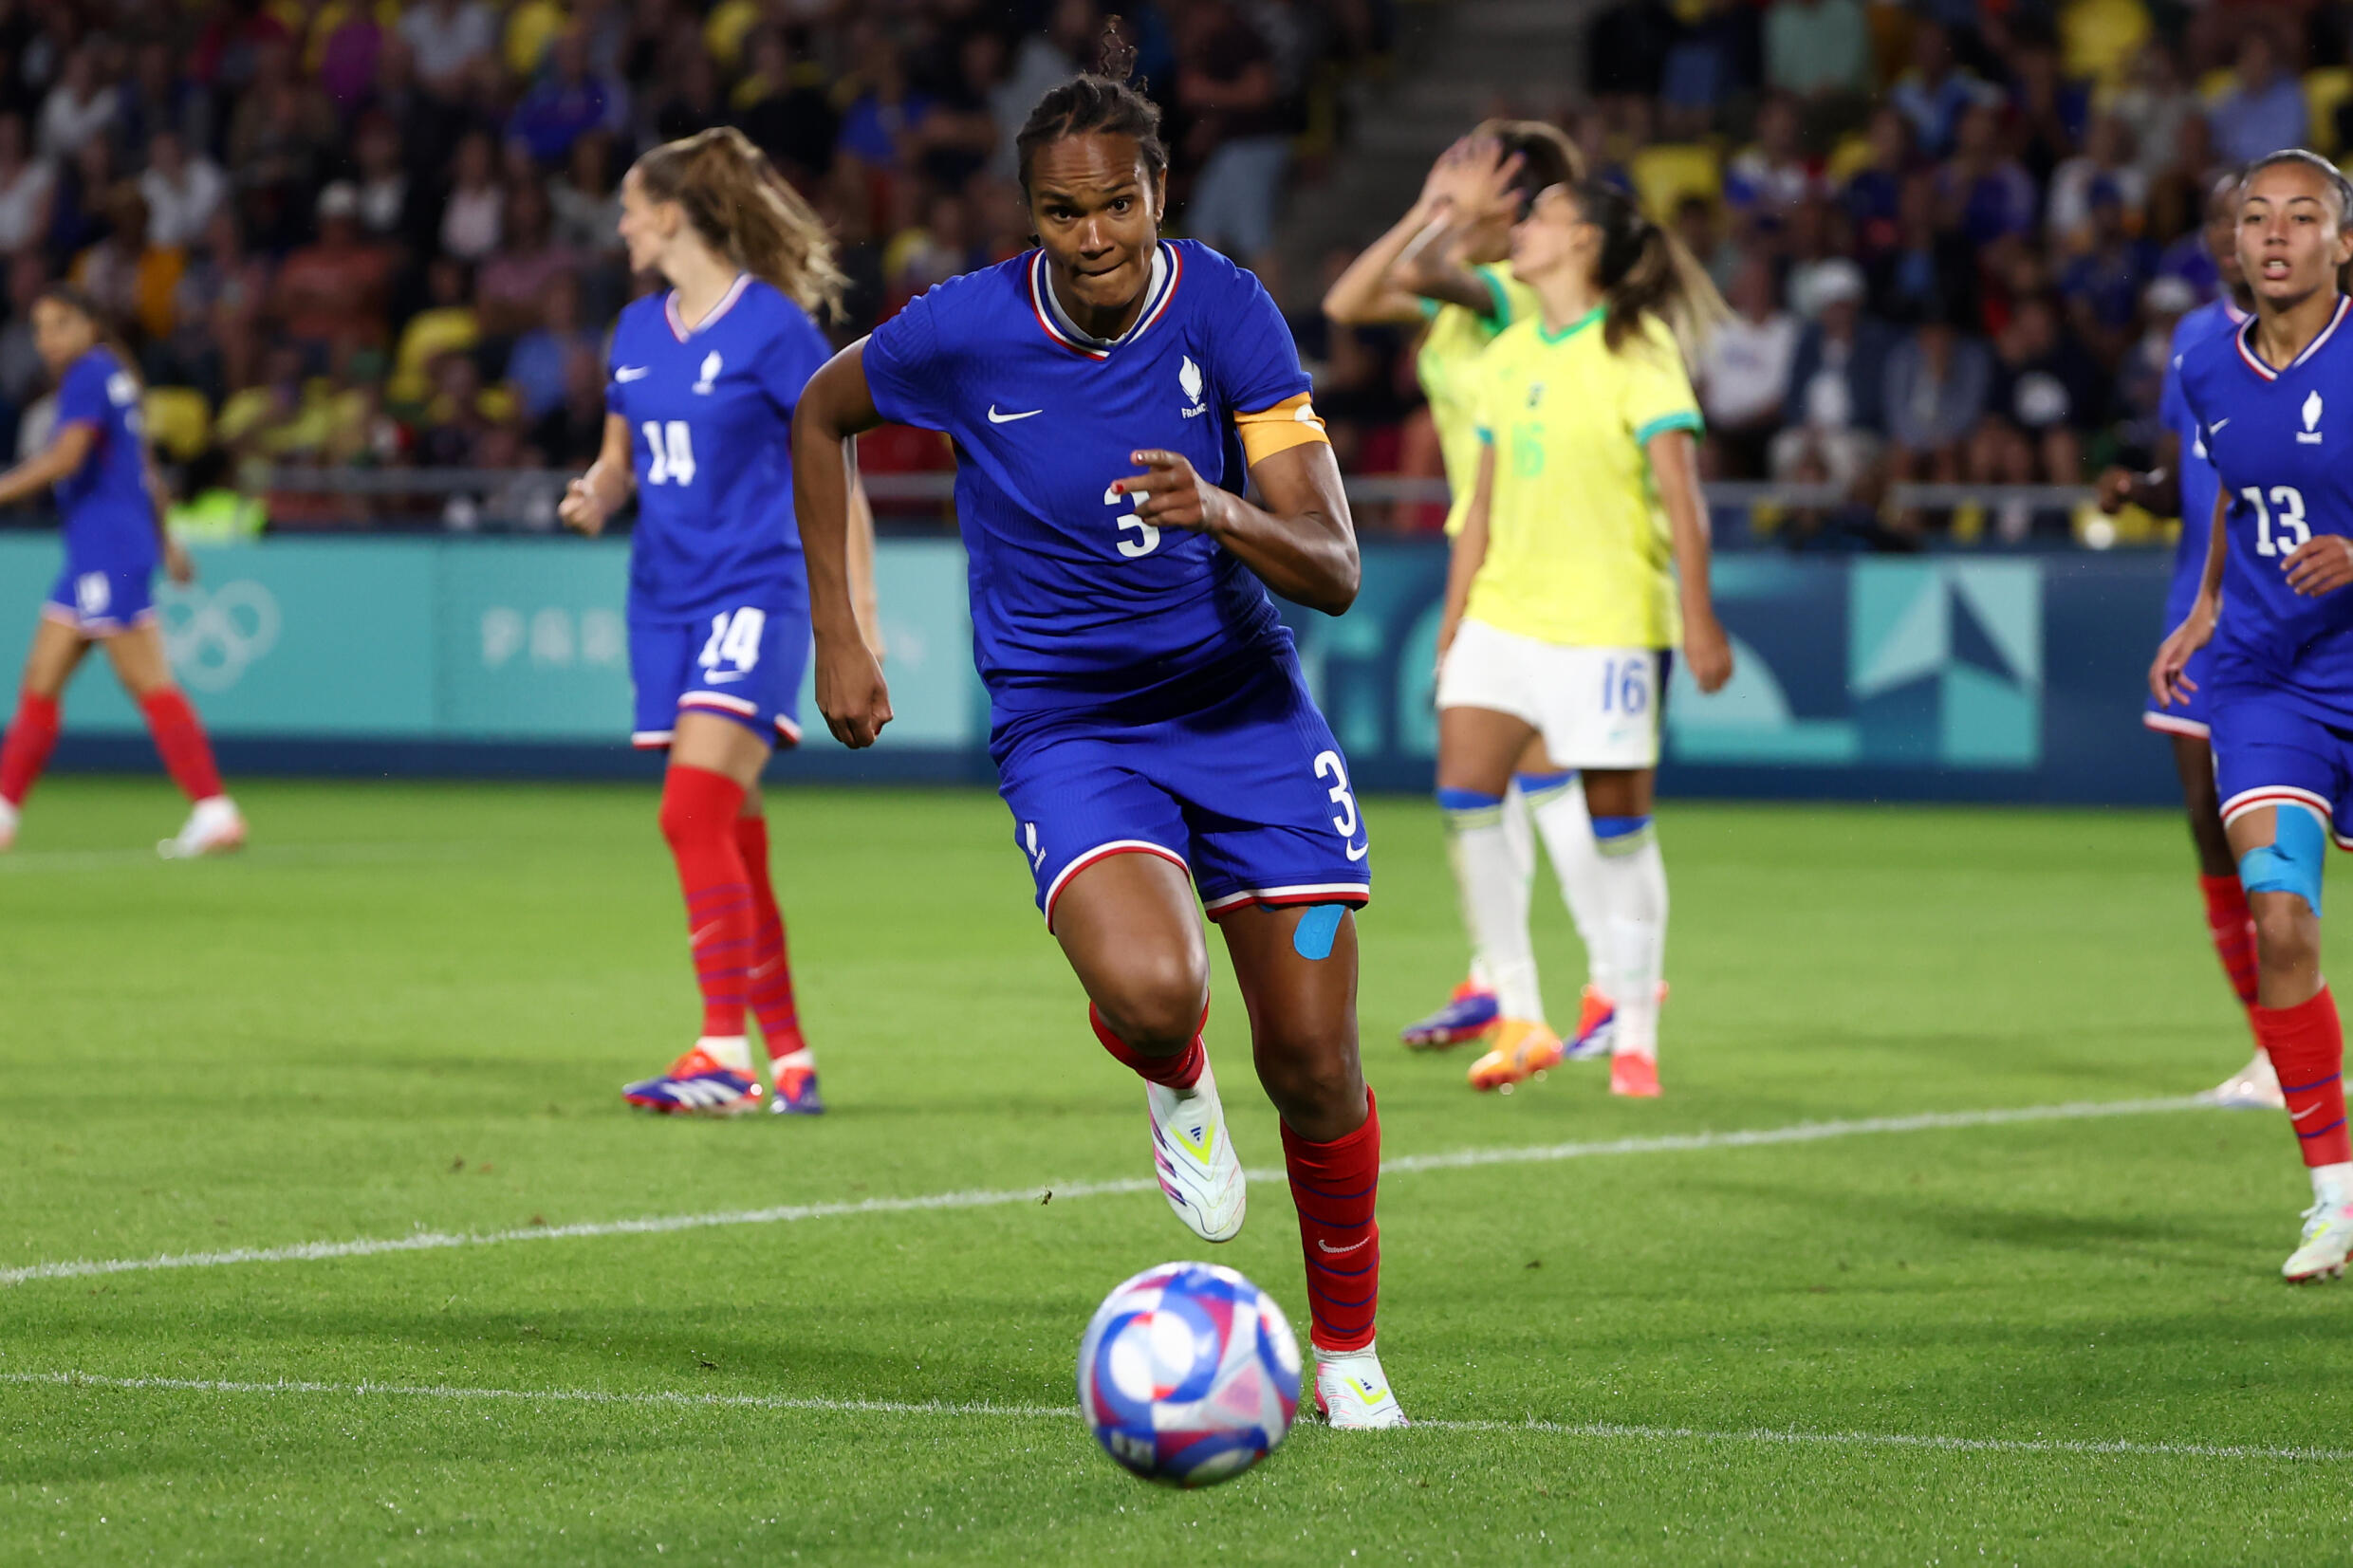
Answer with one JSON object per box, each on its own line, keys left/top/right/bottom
{"left": 2181, "top": 299, "right": 2353, "bottom": 724}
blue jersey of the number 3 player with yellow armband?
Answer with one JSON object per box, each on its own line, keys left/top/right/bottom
{"left": 863, "top": 240, "right": 1308, "bottom": 717}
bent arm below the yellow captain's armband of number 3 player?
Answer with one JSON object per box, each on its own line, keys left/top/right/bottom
{"left": 1111, "top": 439, "right": 1362, "bottom": 616}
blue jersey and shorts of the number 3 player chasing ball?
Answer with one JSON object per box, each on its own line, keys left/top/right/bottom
{"left": 863, "top": 240, "right": 1372, "bottom": 924}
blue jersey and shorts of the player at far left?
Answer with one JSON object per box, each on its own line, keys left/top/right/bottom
{"left": 43, "top": 343, "right": 162, "bottom": 637}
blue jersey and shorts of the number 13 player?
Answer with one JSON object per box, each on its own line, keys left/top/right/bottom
{"left": 2181, "top": 299, "right": 2353, "bottom": 844}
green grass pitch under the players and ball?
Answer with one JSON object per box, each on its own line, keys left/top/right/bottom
{"left": 0, "top": 780, "right": 2353, "bottom": 1566}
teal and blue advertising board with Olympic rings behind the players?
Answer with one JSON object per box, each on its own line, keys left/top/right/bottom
{"left": 0, "top": 536, "right": 2175, "bottom": 804}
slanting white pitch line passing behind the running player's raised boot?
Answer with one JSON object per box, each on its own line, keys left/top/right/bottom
{"left": 0, "top": 1096, "right": 2202, "bottom": 1286}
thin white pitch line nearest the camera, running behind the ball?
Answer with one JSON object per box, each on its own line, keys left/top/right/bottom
{"left": 0, "top": 1373, "right": 2353, "bottom": 1465}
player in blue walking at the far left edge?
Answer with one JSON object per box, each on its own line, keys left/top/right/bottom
{"left": 0, "top": 285, "right": 245, "bottom": 858}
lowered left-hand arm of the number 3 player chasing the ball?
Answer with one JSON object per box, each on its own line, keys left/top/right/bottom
{"left": 793, "top": 339, "right": 892, "bottom": 747}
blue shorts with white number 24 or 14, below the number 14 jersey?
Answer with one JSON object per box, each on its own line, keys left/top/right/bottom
{"left": 628, "top": 604, "right": 809, "bottom": 750}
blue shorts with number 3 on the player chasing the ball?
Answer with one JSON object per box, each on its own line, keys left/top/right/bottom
{"left": 989, "top": 654, "right": 1372, "bottom": 931}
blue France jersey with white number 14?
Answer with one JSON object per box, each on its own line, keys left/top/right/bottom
{"left": 604, "top": 277, "right": 830, "bottom": 620}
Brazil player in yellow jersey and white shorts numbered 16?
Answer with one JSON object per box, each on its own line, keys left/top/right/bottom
{"left": 1437, "top": 181, "right": 1732, "bottom": 1096}
